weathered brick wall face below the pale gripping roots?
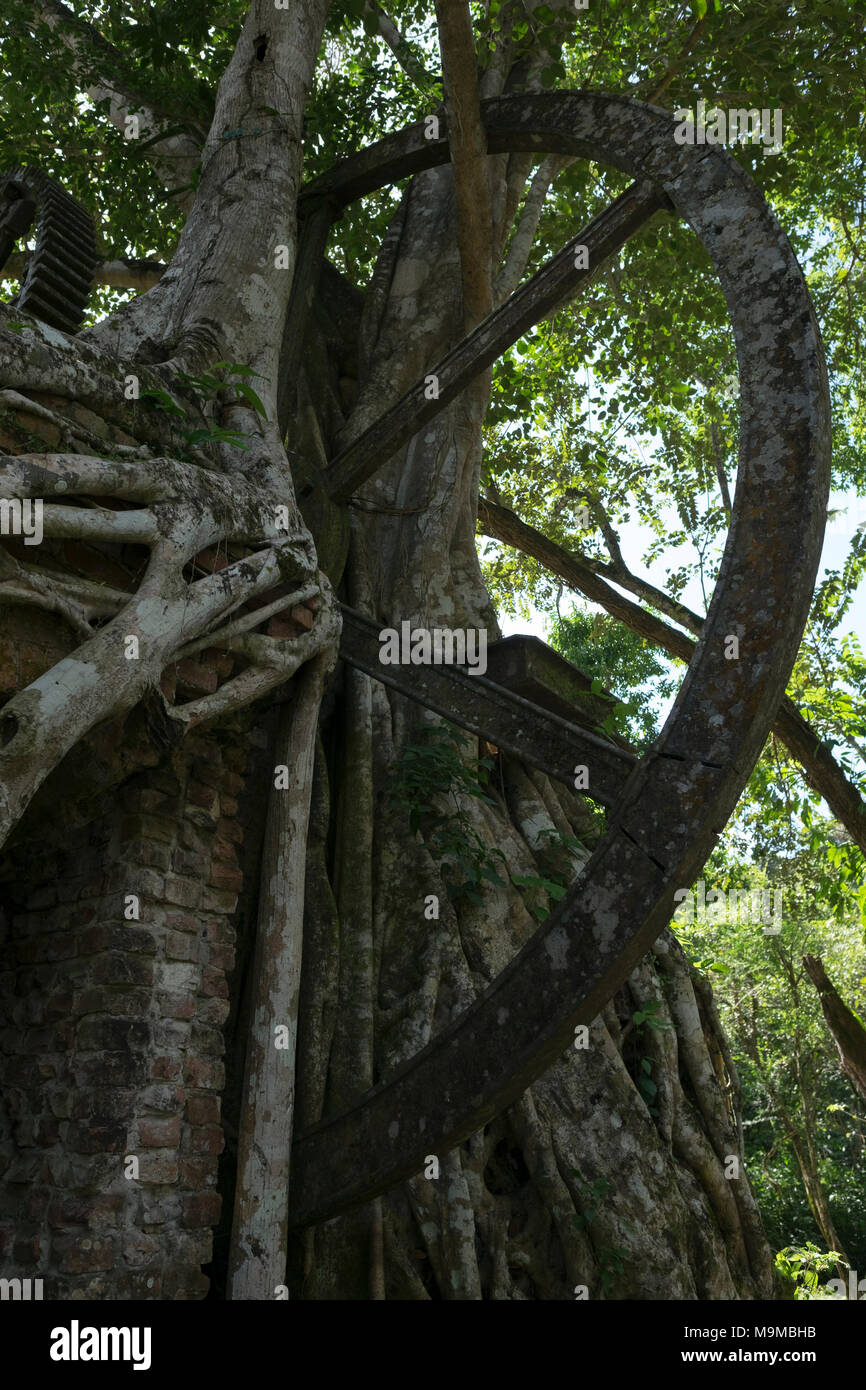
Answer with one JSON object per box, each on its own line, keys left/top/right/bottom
{"left": 0, "top": 711, "right": 257, "bottom": 1298}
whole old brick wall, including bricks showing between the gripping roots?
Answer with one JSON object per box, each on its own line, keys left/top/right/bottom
{"left": 0, "top": 396, "right": 313, "bottom": 1300}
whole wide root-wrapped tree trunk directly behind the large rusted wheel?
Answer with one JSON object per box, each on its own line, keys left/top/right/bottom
{"left": 268, "top": 152, "right": 773, "bottom": 1300}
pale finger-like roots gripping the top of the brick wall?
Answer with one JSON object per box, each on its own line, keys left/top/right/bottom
{"left": 0, "top": 453, "right": 341, "bottom": 844}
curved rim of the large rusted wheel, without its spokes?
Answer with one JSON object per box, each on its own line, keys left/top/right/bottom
{"left": 291, "top": 92, "right": 830, "bottom": 1226}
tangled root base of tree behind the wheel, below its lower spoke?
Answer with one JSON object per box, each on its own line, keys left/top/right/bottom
{"left": 291, "top": 677, "right": 773, "bottom": 1301}
